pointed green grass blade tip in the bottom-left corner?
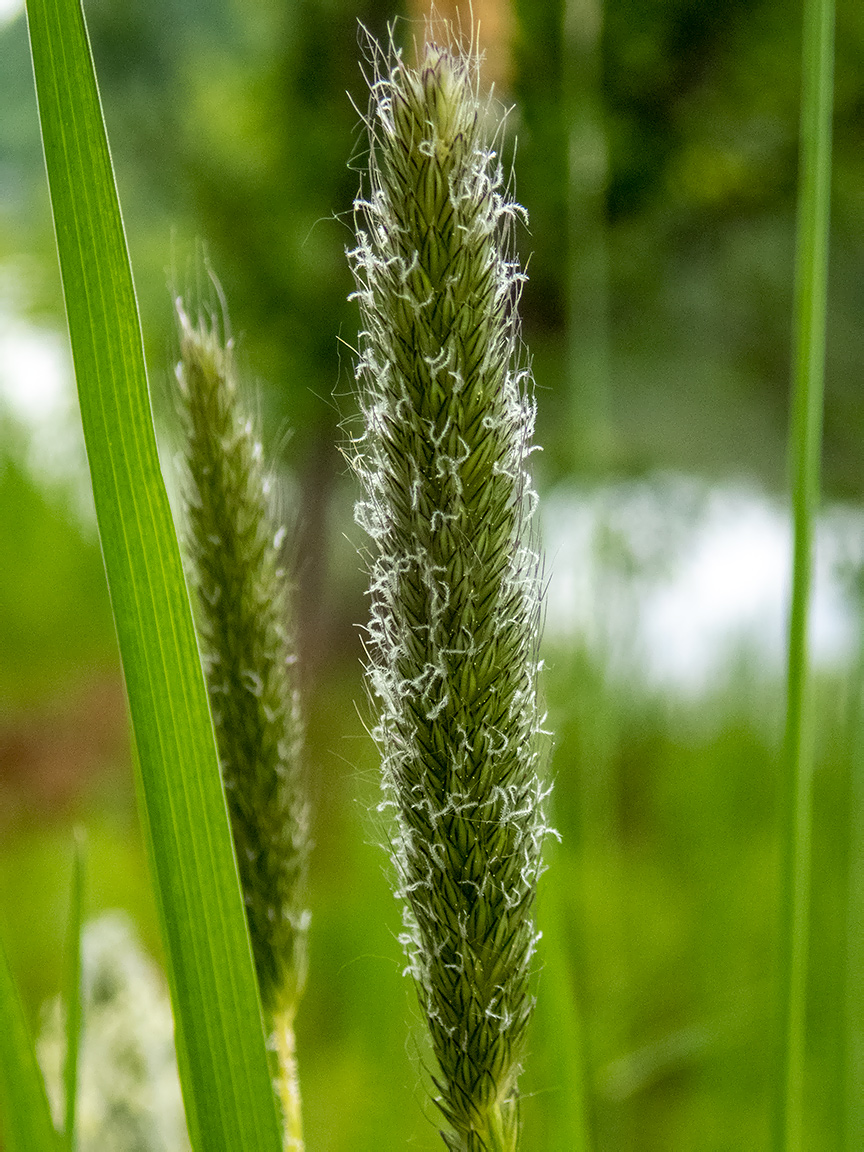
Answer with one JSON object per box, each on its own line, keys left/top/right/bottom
{"left": 0, "top": 930, "right": 60, "bottom": 1152}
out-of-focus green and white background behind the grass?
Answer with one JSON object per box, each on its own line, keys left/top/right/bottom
{"left": 0, "top": 0, "right": 864, "bottom": 1152}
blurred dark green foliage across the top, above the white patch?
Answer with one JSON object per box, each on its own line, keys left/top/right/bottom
{"left": 0, "top": 0, "right": 864, "bottom": 490}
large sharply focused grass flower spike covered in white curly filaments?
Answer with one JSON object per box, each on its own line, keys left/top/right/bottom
{"left": 349, "top": 29, "right": 546, "bottom": 1152}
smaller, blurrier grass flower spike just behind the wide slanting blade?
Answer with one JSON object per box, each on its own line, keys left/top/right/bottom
{"left": 177, "top": 303, "right": 309, "bottom": 1149}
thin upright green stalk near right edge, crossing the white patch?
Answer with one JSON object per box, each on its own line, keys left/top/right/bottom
{"left": 775, "top": 0, "right": 834, "bottom": 1152}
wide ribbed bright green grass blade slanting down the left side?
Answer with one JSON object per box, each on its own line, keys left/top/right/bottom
{"left": 22, "top": 0, "right": 281, "bottom": 1152}
